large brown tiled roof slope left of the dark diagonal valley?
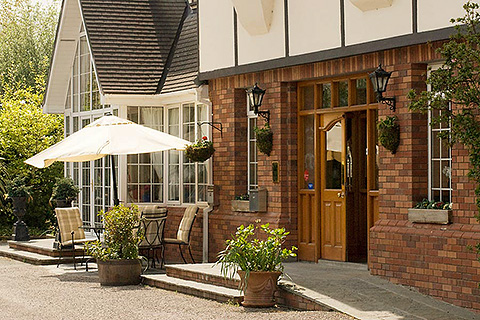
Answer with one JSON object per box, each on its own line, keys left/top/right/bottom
{"left": 80, "top": 0, "right": 188, "bottom": 94}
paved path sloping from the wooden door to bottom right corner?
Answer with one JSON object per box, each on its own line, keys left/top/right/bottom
{"left": 285, "top": 260, "right": 480, "bottom": 320}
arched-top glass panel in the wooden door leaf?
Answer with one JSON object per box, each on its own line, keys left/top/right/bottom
{"left": 325, "top": 122, "right": 343, "bottom": 189}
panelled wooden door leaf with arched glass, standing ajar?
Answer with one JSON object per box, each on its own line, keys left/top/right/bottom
{"left": 320, "top": 113, "right": 347, "bottom": 261}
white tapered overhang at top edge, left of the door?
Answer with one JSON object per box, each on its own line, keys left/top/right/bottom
{"left": 232, "top": 0, "right": 275, "bottom": 36}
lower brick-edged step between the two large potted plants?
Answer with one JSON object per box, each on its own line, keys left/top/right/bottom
{"left": 142, "top": 274, "right": 243, "bottom": 303}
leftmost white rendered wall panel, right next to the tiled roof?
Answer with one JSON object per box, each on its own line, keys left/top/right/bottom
{"left": 198, "top": 0, "right": 235, "bottom": 72}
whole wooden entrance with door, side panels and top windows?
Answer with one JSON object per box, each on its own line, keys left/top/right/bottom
{"left": 297, "top": 74, "right": 379, "bottom": 262}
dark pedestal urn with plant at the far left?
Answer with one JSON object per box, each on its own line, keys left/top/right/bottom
{"left": 6, "top": 176, "right": 32, "bottom": 241}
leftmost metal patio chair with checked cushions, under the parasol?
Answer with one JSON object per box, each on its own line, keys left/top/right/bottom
{"left": 55, "top": 207, "right": 92, "bottom": 270}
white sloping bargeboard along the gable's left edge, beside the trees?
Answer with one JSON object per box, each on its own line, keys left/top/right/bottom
{"left": 43, "top": 0, "right": 82, "bottom": 113}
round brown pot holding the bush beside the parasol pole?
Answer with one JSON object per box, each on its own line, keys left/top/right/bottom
{"left": 97, "top": 259, "right": 142, "bottom": 286}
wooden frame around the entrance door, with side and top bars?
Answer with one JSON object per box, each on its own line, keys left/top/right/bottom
{"left": 297, "top": 73, "right": 379, "bottom": 262}
